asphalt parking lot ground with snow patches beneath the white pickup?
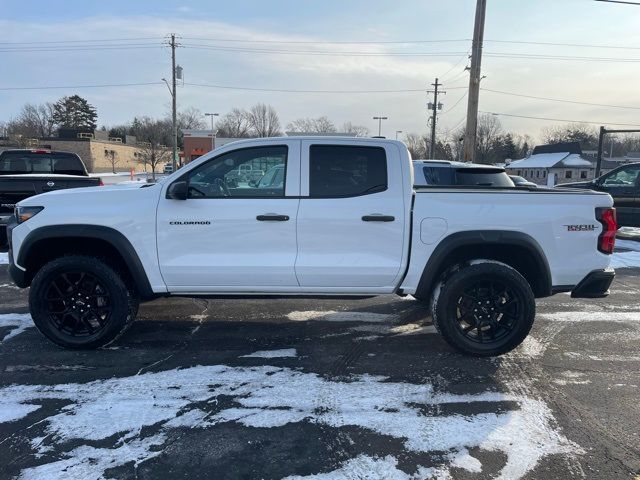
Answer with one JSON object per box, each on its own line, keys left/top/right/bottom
{"left": 0, "top": 253, "right": 640, "bottom": 479}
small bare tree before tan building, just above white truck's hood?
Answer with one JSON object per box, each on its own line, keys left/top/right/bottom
{"left": 132, "top": 117, "right": 171, "bottom": 181}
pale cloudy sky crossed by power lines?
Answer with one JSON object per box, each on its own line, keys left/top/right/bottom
{"left": 0, "top": 0, "right": 640, "bottom": 142}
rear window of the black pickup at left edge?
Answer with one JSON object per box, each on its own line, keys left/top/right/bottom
{"left": 0, "top": 152, "right": 86, "bottom": 176}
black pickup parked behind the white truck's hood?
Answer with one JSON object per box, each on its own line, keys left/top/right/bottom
{"left": 0, "top": 149, "right": 102, "bottom": 246}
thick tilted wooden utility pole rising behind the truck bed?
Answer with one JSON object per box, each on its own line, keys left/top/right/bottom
{"left": 463, "top": 0, "right": 487, "bottom": 162}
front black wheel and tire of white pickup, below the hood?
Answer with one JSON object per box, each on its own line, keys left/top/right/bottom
{"left": 29, "top": 255, "right": 138, "bottom": 349}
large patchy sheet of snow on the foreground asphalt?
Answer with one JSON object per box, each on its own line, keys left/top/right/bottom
{"left": 0, "top": 365, "right": 581, "bottom": 479}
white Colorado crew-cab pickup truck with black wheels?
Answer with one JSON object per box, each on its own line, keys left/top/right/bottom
{"left": 8, "top": 137, "right": 616, "bottom": 355}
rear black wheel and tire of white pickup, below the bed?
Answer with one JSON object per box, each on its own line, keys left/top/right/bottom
{"left": 432, "top": 260, "right": 536, "bottom": 356}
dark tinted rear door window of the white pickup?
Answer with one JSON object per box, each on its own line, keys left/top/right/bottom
{"left": 309, "top": 145, "right": 387, "bottom": 198}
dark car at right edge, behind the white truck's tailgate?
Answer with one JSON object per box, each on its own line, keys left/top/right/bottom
{"left": 558, "top": 163, "right": 640, "bottom": 227}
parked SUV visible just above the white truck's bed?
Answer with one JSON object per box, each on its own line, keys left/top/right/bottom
{"left": 413, "top": 160, "right": 513, "bottom": 187}
